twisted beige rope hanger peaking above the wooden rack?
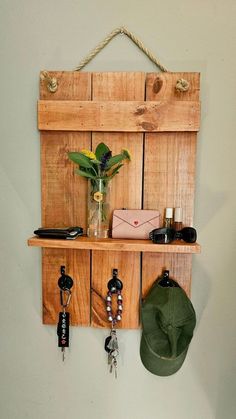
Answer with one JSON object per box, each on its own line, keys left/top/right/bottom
{"left": 75, "top": 27, "right": 168, "bottom": 72}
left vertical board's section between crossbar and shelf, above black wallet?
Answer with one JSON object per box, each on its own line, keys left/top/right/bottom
{"left": 41, "top": 131, "right": 90, "bottom": 231}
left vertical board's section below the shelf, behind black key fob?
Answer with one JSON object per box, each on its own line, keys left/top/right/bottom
{"left": 43, "top": 249, "right": 90, "bottom": 326}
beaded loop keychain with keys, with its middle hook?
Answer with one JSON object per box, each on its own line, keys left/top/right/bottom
{"left": 104, "top": 269, "right": 123, "bottom": 378}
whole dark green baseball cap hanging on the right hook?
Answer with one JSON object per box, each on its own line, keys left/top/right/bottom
{"left": 140, "top": 282, "right": 196, "bottom": 376}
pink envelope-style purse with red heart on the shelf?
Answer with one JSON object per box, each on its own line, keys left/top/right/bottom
{"left": 112, "top": 210, "right": 160, "bottom": 239}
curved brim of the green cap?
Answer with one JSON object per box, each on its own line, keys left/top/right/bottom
{"left": 140, "top": 333, "right": 188, "bottom": 377}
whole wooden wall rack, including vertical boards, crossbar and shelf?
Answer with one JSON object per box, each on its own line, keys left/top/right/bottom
{"left": 28, "top": 72, "right": 200, "bottom": 328}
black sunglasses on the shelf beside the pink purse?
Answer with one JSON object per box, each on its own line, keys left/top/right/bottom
{"left": 149, "top": 227, "right": 197, "bottom": 244}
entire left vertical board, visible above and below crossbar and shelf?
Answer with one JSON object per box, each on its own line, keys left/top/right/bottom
{"left": 40, "top": 72, "right": 91, "bottom": 326}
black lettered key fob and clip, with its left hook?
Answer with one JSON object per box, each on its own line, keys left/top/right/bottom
{"left": 57, "top": 266, "right": 73, "bottom": 361}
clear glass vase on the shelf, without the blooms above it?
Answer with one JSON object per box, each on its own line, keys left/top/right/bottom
{"left": 87, "top": 178, "right": 110, "bottom": 239}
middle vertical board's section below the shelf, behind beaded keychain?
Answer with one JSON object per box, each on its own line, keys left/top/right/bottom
{"left": 92, "top": 251, "right": 140, "bottom": 329}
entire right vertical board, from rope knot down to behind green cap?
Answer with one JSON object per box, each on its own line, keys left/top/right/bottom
{"left": 142, "top": 73, "right": 200, "bottom": 296}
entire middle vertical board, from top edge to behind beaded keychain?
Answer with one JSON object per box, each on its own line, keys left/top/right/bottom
{"left": 92, "top": 73, "right": 145, "bottom": 329}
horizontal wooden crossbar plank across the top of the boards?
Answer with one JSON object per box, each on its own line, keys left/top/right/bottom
{"left": 38, "top": 100, "right": 200, "bottom": 132}
